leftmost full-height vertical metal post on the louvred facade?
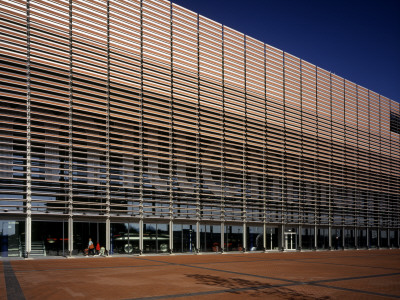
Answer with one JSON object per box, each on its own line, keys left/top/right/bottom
{"left": 25, "top": 0, "right": 32, "bottom": 258}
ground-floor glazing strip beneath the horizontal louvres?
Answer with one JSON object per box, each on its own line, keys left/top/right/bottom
{"left": 0, "top": 218, "right": 400, "bottom": 257}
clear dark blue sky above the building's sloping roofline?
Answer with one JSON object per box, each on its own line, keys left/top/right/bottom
{"left": 172, "top": 0, "right": 400, "bottom": 102}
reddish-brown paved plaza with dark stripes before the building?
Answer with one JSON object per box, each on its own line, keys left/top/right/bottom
{"left": 0, "top": 249, "right": 400, "bottom": 300}
